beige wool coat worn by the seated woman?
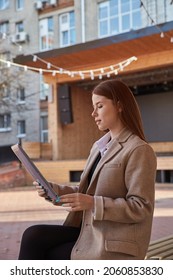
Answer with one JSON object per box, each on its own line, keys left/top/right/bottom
{"left": 52, "top": 130, "right": 156, "bottom": 260}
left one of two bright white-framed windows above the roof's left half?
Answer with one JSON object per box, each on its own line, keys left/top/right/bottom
{"left": 39, "top": 17, "right": 54, "bottom": 50}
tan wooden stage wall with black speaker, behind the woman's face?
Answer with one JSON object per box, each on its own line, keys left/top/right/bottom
{"left": 49, "top": 84, "right": 103, "bottom": 160}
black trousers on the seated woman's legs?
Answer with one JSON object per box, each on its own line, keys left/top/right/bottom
{"left": 19, "top": 225, "right": 80, "bottom": 260}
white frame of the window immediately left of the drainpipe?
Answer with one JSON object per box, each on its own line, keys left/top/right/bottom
{"left": 59, "top": 11, "right": 76, "bottom": 47}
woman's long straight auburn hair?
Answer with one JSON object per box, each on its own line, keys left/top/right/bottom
{"left": 92, "top": 79, "right": 146, "bottom": 141}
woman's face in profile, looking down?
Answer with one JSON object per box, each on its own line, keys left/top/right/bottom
{"left": 92, "top": 94, "right": 123, "bottom": 135}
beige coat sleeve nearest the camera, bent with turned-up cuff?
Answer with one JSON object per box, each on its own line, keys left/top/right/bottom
{"left": 94, "top": 144, "right": 156, "bottom": 223}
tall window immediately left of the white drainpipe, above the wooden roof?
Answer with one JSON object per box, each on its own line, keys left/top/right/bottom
{"left": 59, "top": 12, "right": 76, "bottom": 47}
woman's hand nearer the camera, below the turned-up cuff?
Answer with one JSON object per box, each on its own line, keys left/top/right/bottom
{"left": 57, "top": 193, "right": 94, "bottom": 211}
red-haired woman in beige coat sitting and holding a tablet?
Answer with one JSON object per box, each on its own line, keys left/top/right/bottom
{"left": 19, "top": 80, "right": 156, "bottom": 260}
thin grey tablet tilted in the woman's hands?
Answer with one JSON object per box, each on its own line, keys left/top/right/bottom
{"left": 11, "top": 144, "right": 58, "bottom": 200}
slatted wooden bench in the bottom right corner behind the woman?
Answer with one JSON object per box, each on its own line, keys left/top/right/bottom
{"left": 145, "top": 235, "right": 173, "bottom": 260}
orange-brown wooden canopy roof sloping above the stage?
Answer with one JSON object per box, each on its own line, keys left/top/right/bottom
{"left": 15, "top": 22, "right": 173, "bottom": 83}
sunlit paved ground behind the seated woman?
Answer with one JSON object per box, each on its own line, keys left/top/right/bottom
{"left": 0, "top": 184, "right": 173, "bottom": 260}
